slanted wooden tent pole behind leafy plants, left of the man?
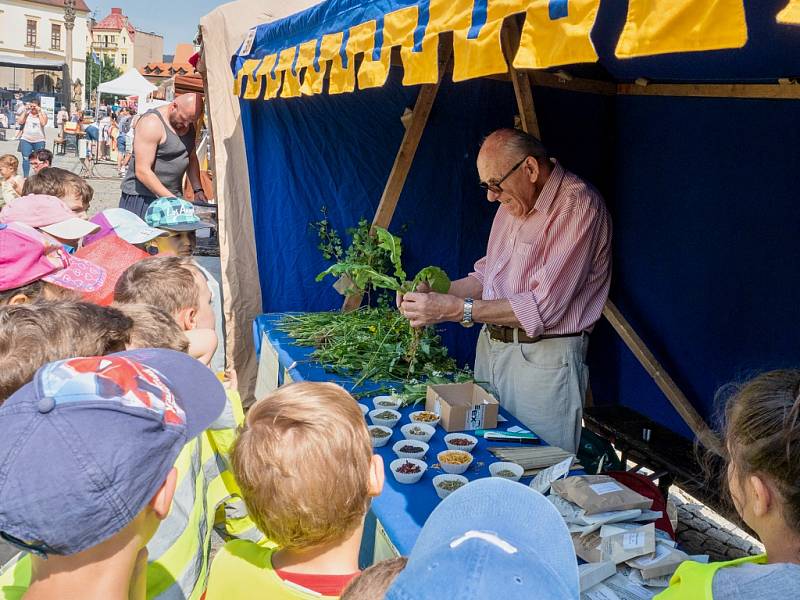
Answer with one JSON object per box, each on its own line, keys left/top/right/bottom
{"left": 342, "top": 39, "right": 453, "bottom": 312}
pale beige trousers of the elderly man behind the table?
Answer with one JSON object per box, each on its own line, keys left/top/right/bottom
{"left": 475, "top": 327, "right": 589, "bottom": 452}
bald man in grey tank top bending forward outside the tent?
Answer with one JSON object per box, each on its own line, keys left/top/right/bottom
{"left": 119, "top": 94, "right": 206, "bottom": 219}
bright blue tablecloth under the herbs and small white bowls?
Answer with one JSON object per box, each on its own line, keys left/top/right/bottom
{"left": 253, "top": 313, "right": 582, "bottom": 556}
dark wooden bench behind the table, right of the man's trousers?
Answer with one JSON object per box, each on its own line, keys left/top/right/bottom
{"left": 583, "top": 406, "right": 738, "bottom": 521}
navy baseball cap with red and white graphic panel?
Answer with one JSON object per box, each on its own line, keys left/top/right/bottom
{"left": 0, "top": 349, "right": 225, "bottom": 556}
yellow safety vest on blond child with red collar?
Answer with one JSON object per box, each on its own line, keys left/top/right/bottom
{"left": 206, "top": 540, "right": 338, "bottom": 600}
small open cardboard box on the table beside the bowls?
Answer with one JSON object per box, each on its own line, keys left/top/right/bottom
{"left": 425, "top": 383, "right": 500, "bottom": 431}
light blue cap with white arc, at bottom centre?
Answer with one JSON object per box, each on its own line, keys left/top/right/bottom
{"left": 385, "top": 477, "right": 580, "bottom": 600}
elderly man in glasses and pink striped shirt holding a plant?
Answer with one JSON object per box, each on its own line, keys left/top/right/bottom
{"left": 399, "top": 129, "right": 611, "bottom": 452}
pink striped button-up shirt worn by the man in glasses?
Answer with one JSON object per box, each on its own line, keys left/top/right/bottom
{"left": 470, "top": 161, "right": 611, "bottom": 337}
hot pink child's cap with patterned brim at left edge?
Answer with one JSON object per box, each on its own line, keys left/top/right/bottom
{"left": 0, "top": 223, "right": 106, "bottom": 292}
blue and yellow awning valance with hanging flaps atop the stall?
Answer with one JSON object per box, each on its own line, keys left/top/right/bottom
{"left": 232, "top": 0, "right": 756, "bottom": 100}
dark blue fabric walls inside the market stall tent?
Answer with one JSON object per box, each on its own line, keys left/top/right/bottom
{"left": 241, "top": 0, "right": 800, "bottom": 436}
